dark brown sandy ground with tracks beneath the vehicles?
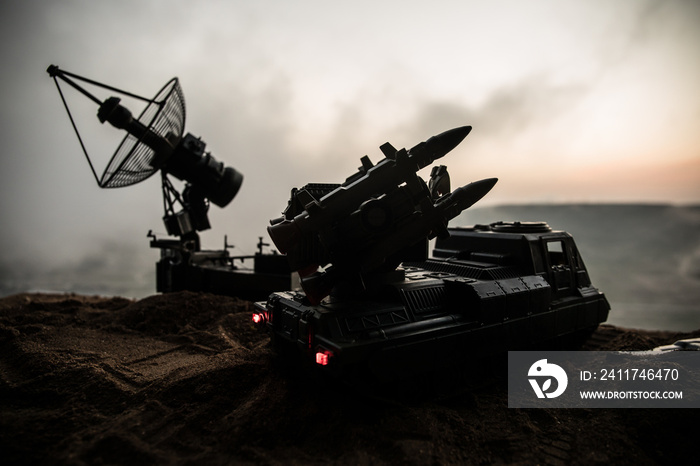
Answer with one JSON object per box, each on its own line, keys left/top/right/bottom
{"left": 0, "top": 292, "right": 700, "bottom": 465}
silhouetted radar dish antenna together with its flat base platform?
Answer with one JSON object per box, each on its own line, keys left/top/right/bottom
{"left": 47, "top": 65, "right": 291, "bottom": 299}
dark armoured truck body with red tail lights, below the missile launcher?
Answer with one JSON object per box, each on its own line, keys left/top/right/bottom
{"left": 256, "top": 222, "right": 610, "bottom": 380}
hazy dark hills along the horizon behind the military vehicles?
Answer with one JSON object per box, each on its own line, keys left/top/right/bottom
{"left": 0, "top": 204, "right": 700, "bottom": 331}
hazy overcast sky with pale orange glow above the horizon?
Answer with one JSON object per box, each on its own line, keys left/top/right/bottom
{"left": 0, "top": 0, "right": 700, "bottom": 290}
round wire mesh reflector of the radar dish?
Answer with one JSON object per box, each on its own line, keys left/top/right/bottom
{"left": 100, "top": 78, "right": 185, "bottom": 188}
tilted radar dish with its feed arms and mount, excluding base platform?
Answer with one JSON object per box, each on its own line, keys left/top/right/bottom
{"left": 47, "top": 65, "right": 243, "bottom": 235}
